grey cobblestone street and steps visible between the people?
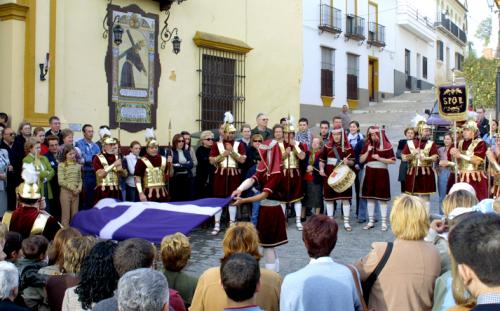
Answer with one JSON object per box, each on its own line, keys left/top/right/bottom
{"left": 187, "top": 92, "right": 438, "bottom": 276}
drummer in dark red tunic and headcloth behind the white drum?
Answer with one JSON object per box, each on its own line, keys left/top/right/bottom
{"left": 319, "top": 127, "right": 354, "bottom": 231}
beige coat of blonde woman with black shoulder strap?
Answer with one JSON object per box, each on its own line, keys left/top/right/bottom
{"left": 356, "top": 239, "right": 441, "bottom": 311}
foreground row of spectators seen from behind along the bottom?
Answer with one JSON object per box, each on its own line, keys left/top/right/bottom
{"left": 0, "top": 190, "right": 500, "bottom": 311}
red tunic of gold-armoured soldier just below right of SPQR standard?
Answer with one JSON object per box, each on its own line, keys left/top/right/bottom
{"left": 447, "top": 139, "right": 488, "bottom": 201}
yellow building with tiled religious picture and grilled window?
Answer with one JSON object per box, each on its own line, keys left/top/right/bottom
{"left": 0, "top": 0, "right": 303, "bottom": 145}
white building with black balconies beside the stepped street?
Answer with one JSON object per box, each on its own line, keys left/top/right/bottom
{"left": 300, "top": 0, "right": 470, "bottom": 124}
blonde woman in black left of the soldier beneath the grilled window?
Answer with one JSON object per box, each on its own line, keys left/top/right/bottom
{"left": 194, "top": 131, "right": 215, "bottom": 199}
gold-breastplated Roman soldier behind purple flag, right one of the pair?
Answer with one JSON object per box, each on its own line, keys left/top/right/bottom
{"left": 134, "top": 129, "right": 173, "bottom": 202}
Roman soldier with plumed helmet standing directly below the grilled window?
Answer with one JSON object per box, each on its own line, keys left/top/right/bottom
{"left": 210, "top": 111, "right": 246, "bottom": 235}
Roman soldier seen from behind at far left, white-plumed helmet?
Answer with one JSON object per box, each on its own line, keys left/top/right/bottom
{"left": 2, "top": 164, "right": 62, "bottom": 241}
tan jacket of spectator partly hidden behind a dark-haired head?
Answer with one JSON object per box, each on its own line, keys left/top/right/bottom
{"left": 189, "top": 267, "right": 281, "bottom": 311}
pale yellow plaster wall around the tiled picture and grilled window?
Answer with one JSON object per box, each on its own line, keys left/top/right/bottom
{"left": 0, "top": 0, "right": 303, "bottom": 144}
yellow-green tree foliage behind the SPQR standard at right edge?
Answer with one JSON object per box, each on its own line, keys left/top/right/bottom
{"left": 463, "top": 55, "right": 500, "bottom": 107}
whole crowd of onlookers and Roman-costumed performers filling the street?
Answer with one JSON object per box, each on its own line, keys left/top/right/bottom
{"left": 0, "top": 105, "right": 500, "bottom": 311}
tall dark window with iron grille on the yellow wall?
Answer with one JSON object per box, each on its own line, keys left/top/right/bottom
{"left": 198, "top": 48, "right": 245, "bottom": 130}
